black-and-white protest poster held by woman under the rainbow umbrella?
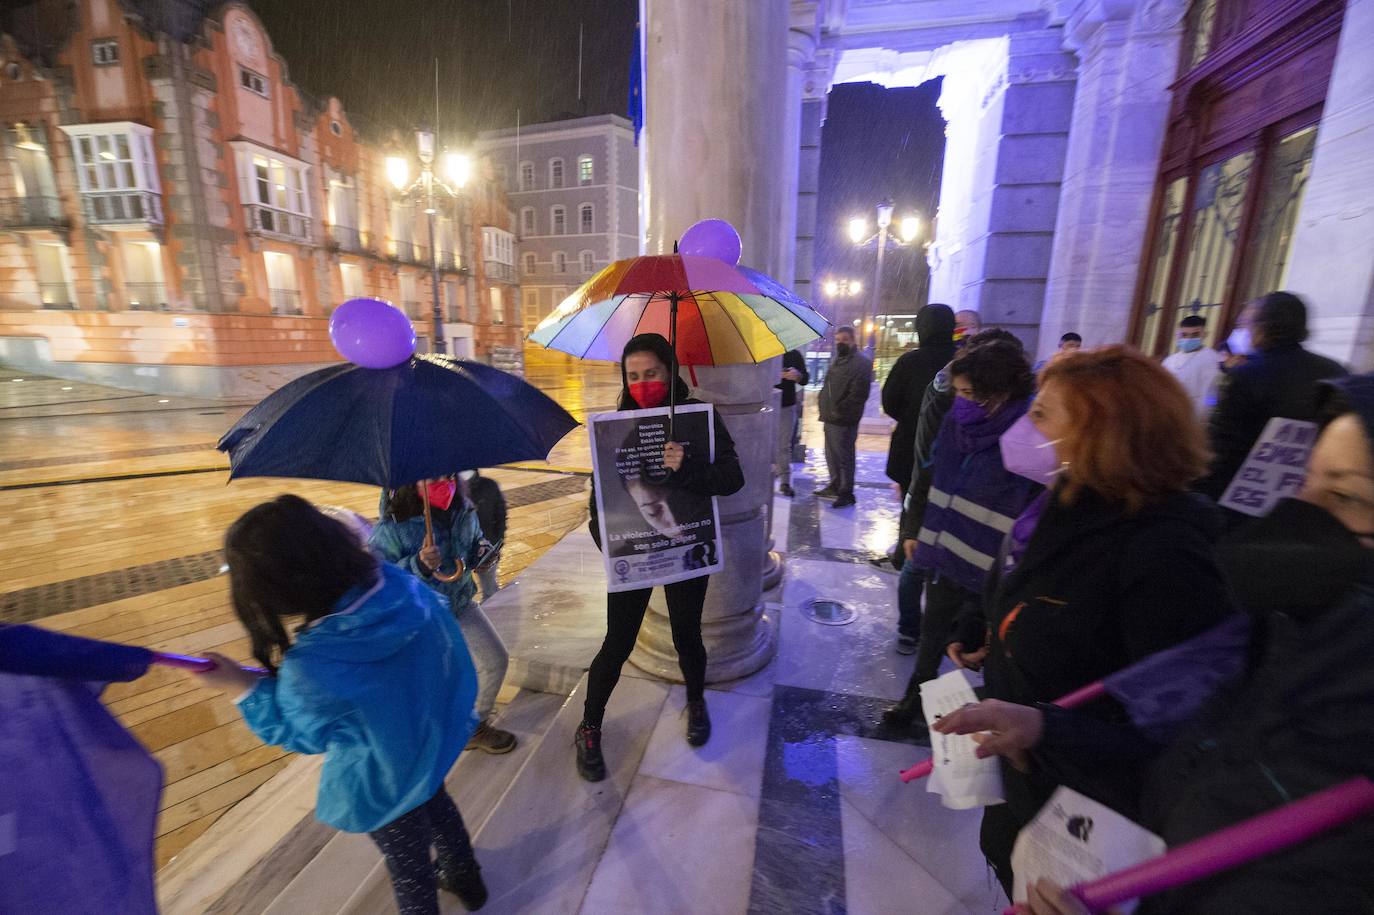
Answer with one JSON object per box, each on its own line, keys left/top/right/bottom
{"left": 588, "top": 404, "right": 724, "bottom": 591}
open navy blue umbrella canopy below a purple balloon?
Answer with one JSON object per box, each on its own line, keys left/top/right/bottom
{"left": 218, "top": 354, "right": 578, "bottom": 489}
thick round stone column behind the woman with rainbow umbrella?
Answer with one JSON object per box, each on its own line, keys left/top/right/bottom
{"left": 631, "top": 0, "right": 789, "bottom": 681}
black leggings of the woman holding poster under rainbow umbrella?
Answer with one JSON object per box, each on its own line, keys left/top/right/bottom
{"left": 583, "top": 576, "right": 710, "bottom": 728}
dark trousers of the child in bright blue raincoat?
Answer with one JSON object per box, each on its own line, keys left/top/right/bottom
{"left": 371, "top": 787, "right": 477, "bottom": 915}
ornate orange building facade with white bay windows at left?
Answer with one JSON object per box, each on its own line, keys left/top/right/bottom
{"left": 0, "top": 0, "right": 521, "bottom": 397}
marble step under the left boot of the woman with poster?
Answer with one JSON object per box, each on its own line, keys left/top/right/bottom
{"left": 338, "top": 669, "right": 669, "bottom": 915}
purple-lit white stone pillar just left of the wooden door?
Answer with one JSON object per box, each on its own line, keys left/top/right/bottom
{"left": 1039, "top": 0, "right": 1187, "bottom": 357}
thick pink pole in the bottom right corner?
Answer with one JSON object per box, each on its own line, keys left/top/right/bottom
{"left": 1004, "top": 778, "right": 1374, "bottom": 915}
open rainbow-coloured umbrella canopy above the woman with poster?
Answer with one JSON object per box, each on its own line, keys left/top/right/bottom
{"left": 529, "top": 254, "right": 830, "bottom": 365}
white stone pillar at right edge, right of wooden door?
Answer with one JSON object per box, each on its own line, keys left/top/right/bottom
{"left": 1285, "top": 0, "right": 1374, "bottom": 372}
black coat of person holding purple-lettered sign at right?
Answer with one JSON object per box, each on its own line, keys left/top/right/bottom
{"left": 1194, "top": 343, "right": 1347, "bottom": 499}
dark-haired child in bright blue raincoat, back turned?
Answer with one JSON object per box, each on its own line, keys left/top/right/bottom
{"left": 201, "top": 496, "right": 486, "bottom": 915}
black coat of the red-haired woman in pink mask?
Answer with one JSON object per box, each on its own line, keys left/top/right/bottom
{"left": 951, "top": 490, "right": 1232, "bottom": 826}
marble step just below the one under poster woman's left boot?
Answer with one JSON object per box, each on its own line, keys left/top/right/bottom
{"left": 262, "top": 690, "right": 566, "bottom": 915}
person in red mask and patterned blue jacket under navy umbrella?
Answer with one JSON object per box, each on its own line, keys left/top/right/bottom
{"left": 370, "top": 477, "right": 515, "bottom": 753}
